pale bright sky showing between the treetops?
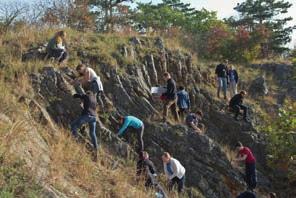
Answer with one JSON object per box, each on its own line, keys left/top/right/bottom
{"left": 138, "top": 0, "right": 296, "bottom": 48}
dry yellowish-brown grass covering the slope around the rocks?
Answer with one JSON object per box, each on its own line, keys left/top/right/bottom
{"left": 0, "top": 27, "right": 286, "bottom": 197}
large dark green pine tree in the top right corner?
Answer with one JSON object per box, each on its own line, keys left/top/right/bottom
{"left": 234, "top": 0, "right": 295, "bottom": 53}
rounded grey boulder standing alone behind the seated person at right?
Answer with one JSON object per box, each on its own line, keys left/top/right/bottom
{"left": 249, "top": 76, "right": 268, "bottom": 97}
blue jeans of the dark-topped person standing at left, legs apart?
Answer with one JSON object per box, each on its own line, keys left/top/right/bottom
{"left": 71, "top": 115, "right": 98, "bottom": 150}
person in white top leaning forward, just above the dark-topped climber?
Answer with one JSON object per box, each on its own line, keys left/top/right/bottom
{"left": 75, "top": 64, "right": 107, "bottom": 111}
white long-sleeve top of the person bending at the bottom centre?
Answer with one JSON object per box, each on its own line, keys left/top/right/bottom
{"left": 163, "top": 158, "right": 185, "bottom": 180}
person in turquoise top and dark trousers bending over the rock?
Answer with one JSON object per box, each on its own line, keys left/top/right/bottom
{"left": 117, "top": 115, "right": 144, "bottom": 155}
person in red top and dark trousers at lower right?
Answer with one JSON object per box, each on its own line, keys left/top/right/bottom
{"left": 234, "top": 142, "right": 257, "bottom": 191}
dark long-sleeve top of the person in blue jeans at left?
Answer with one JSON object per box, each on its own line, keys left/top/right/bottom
{"left": 74, "top": 93, "right": 97, "bottom": 116}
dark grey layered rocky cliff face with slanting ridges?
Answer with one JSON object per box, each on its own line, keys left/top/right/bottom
{"left": 18, "top": 38, "right": 278, "bottom": 198}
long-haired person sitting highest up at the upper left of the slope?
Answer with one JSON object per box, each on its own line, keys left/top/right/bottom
{"left": 46, "top": 31, "right": 68, "bottom": 64}
